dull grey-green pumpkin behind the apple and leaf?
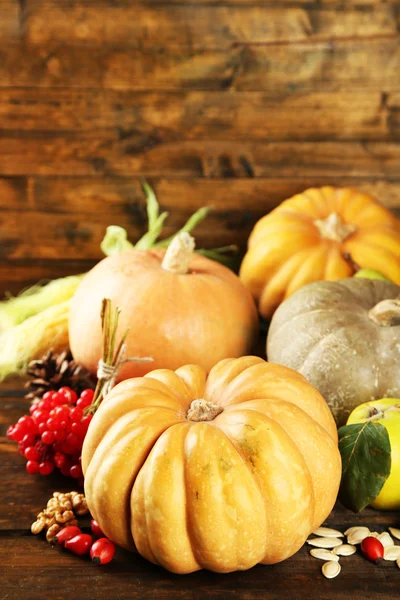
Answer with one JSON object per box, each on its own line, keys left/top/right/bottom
{"left": 267, "top": 278, "right": 400, "bottom": 425}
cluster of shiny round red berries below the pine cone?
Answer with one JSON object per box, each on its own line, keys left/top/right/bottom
{"left": 7, "top": 387, "right": 94, "bottom": 481}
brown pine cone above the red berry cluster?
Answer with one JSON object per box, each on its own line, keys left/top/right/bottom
{"left": 25, "top": 350, "right": 94, "bottom": 400}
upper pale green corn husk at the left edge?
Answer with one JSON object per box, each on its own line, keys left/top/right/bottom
{"left": 0, "top": 275, "right": 83, "bottom": 332}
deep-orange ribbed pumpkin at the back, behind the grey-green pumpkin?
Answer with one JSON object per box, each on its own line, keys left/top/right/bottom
{"left": 240, "top": 187, "right": 400, "bottom": 317}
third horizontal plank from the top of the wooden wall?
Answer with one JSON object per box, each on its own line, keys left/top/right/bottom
{"left": 0, "top": 88, "right": 400, "bottom": 145}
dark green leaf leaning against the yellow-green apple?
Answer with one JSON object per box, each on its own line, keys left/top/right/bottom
{"left": 339, "top": 421, "right": 391, "bottom": 512}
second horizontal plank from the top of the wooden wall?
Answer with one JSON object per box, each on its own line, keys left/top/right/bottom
{"left": 0, "top": 36, "right": 400, "bottom": 93}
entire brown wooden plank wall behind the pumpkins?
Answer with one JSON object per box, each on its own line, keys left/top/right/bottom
{"left": 0, "top": 0, "right": 400, "bottom": 291}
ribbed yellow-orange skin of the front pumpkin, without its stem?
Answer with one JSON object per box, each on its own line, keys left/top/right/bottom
{"left": 82, "top": 356, "right": 341, "bottom": 573}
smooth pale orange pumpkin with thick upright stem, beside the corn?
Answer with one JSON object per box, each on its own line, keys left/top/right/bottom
{"left": 69, "top": 233, "right": 258, "bottom": 379}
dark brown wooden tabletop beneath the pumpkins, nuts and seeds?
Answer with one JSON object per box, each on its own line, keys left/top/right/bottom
{"left": 0, "top": 382, "right": 400, "bottom": 600}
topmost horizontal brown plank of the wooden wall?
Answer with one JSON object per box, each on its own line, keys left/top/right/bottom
{"left": 22, "top": 0, "right": 399, "bottom": 50}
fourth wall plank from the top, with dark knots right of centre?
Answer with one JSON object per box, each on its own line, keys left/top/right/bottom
{"left": 0, "top": 139, "right": 399, "bottom": 179}
